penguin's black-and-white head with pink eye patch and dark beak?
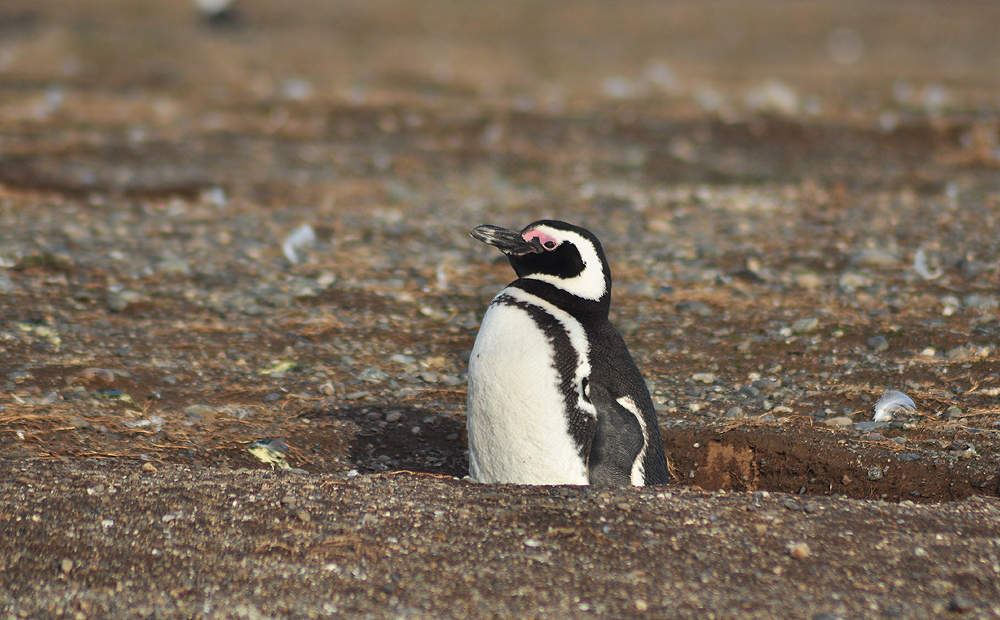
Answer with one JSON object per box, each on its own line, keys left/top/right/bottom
{"left": 471, "top": 220, "right": 611, "bottom": 302}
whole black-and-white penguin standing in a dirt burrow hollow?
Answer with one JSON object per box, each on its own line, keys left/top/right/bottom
{"left": 467, "top": 220, "right": 669, "bottom": 486}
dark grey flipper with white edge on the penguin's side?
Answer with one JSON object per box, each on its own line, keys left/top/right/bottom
{"left": 587, "top": 382, "right": 645, "bottom": 486}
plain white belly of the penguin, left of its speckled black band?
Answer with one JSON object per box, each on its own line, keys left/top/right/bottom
{"left": 468, "top": 305, "right": 588, "bottom": 484}
